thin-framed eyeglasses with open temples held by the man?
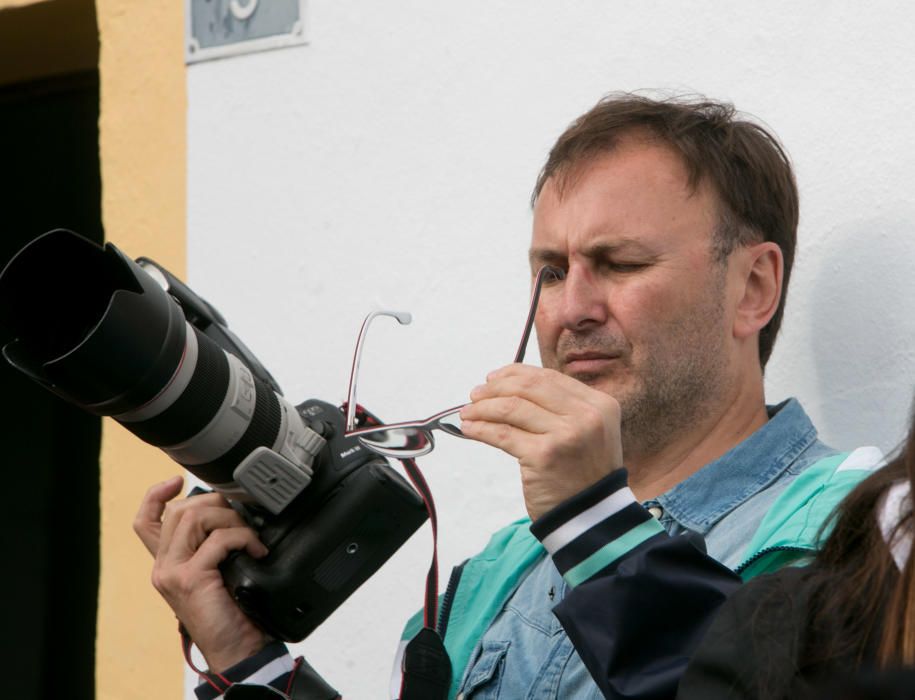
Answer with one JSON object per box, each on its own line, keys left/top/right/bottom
{"left": 346, "top": 265, "right": 565, "bottom": 459}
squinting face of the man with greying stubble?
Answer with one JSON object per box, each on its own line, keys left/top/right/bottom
{"left": 530, "top": 140, "right": 730, "bottom": 452}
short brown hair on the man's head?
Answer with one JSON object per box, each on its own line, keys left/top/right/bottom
{"left": 531, "top": 93, "right": 798, "bottom": 367}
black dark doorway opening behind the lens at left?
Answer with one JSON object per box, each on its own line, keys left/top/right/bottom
{"left": 0, "top": 64, "right": 103, "bottom": 700}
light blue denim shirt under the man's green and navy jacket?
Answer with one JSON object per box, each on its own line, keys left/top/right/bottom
{"left": 455, "top": 399, "right": 836, "bottom": 700}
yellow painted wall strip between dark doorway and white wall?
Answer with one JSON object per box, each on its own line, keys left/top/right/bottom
{"left": 96, "top": 0, "right": 187, "bottom": 700}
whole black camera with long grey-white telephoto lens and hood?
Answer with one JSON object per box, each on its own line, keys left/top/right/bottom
{"left": 0, "top": 229, "right": 428, "bottom": 641}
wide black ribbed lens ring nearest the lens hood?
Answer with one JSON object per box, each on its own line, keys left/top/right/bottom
{"left": 122, "top": 326, "right": 229, "bottom": 447}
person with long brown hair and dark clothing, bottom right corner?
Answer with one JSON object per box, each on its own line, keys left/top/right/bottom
{"left": 677, "top": 408, "right": 915, "bottom": 700}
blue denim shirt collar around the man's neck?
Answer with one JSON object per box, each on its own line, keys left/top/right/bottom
{"left": 656, "top": 399, "right": 817, "bottom": 535}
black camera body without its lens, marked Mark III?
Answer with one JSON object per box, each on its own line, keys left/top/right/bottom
{"left": 222, "top": 400, "right": 428, "bottom": 641}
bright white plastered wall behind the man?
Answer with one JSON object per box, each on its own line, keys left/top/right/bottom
{"left": 188, "top": 0, "right": 915, "bottom": 698}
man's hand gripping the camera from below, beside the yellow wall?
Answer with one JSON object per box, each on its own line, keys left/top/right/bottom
{"left": 133, "top": 476, "right": 267, "bottom": 672}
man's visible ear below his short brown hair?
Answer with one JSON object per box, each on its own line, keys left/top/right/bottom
{"left": 731, "top": 241, "right": 784, "bottom": 339}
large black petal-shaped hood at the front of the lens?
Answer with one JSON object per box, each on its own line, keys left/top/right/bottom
{"left": 0, "top": 229, "right": 187, "bottom": 415}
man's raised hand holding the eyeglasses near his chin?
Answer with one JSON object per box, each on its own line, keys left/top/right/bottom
{"left": 461, "top": 364, "right": 623, "bottom": 520}
